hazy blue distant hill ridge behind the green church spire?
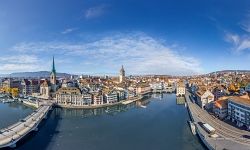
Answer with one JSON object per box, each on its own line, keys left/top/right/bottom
{"left": 0, "top": 71, "right": 71, "bottom": 78}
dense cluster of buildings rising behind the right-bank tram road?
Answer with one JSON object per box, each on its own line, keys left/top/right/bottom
{"left": 187, "top": 72, "right": 250, "bottom": 130}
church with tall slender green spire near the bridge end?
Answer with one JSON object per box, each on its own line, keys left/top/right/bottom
{"left": 40, "top": 56, "right": 58, "bottom": 99}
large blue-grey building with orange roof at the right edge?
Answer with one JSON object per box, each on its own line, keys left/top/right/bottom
{"left": 228, "top": 96, "right": 250, "bottom": 130}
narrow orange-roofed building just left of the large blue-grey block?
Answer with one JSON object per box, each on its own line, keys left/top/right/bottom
{"left": 213, "top": 97, "right": 229, "bottom": 119}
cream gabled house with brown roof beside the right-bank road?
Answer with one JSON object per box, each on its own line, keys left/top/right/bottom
{"left": 196, "top": 89, "right": 214, "bottom": 109}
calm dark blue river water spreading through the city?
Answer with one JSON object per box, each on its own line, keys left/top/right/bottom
{"left": 0, "top": 94, "right": 205, "bottom": 150}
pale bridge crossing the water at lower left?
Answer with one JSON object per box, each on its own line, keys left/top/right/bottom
{"left": 0, "top": 105, "right": 52, "bottom": 148}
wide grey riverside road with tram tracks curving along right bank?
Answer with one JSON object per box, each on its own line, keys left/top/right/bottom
{"left": 186, "top": 91, "right": 250, "bottom": 150}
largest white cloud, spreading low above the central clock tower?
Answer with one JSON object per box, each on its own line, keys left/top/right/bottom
{"left": 12, "top": 32, "right": 203, "bottom": 75}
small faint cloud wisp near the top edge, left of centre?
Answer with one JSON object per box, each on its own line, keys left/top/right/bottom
{"left": 85, "top": 5, "right": 107, "bottom": 19}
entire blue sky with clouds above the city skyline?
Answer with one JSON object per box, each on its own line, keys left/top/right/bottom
{"left": 0, "top": 0, "right": 250, "bottom": 75}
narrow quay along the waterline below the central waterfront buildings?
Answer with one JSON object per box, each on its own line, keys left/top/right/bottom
{"left": 54, "top": 97, "right": 143, "bottom": 109}
